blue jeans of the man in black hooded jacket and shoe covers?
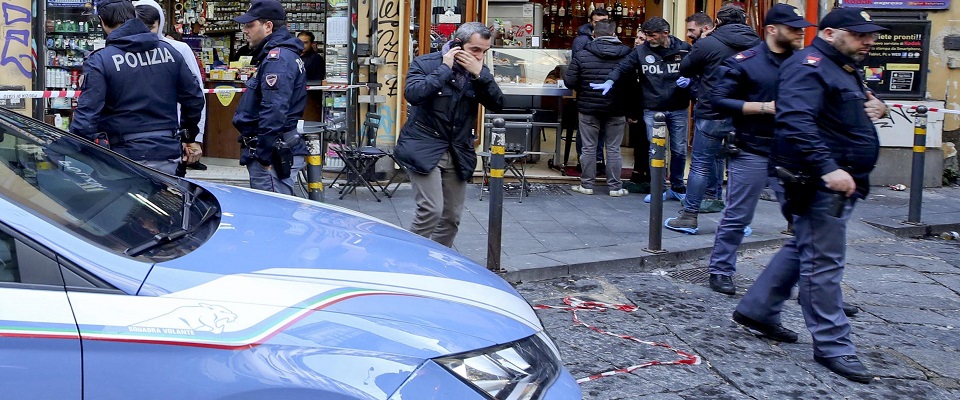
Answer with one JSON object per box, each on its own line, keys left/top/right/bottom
{"left": 683, "top": 118, "right": 733, "bottom": 213}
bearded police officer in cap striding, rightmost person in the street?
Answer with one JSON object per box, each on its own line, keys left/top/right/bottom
{"left": 733, "top": 8, "right": 886, "bottom": 383}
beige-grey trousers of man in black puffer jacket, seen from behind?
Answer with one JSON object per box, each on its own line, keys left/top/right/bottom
{"left": 580, "top": 113, "right": 627, "bottom": 190}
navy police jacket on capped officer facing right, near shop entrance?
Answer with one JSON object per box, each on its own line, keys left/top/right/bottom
{"left": 233, "top": 27, "right": 307, "bottom": 165}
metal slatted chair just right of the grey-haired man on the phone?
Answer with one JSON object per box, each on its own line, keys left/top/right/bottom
{"left": 477, "top": 114, "right": 533, "bottom": 203}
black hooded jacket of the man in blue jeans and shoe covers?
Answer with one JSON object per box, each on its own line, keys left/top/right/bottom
{"left": 680, "top": 24, "right": 760, "bottom": 119}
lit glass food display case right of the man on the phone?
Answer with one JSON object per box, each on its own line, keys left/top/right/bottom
{"left": 486, "top": 48, "right": 571, "bottom": 96}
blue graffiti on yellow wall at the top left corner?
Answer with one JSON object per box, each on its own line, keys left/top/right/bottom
{"left": 0, "top": 1, "right": 33, "bottom": 79}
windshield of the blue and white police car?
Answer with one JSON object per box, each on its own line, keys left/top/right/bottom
{"left": 0, "top": 108, "right": 219, "bottom": 262}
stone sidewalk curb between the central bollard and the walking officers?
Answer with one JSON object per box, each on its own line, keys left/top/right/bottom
{"left": 501, "top": 235, "right": 790, "bottom": 284}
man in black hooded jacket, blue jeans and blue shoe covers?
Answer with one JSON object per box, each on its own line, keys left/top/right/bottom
{"left": 664, "top": 4, "right": 760, "bottom": 235}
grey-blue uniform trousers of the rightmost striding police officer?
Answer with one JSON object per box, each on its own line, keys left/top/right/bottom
{"left": 737, "top": 185, "right": 857, "bottom": 357}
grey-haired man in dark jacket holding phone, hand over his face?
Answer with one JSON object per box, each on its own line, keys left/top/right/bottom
{"left": 394, "top": 22, "right": 503, "bottom": 247}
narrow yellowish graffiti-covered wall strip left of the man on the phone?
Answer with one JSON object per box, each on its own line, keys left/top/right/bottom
{"left": 374, "top": 0, "right": 403, "bottom": 146}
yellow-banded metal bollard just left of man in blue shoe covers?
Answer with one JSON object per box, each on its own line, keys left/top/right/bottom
{"left": 643, "top": 112, "right": 667, "bottom": 253}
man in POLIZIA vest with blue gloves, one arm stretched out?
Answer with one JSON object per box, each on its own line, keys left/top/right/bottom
{"left": 590, "top": 17, "right": 690, "bottom": 203}
